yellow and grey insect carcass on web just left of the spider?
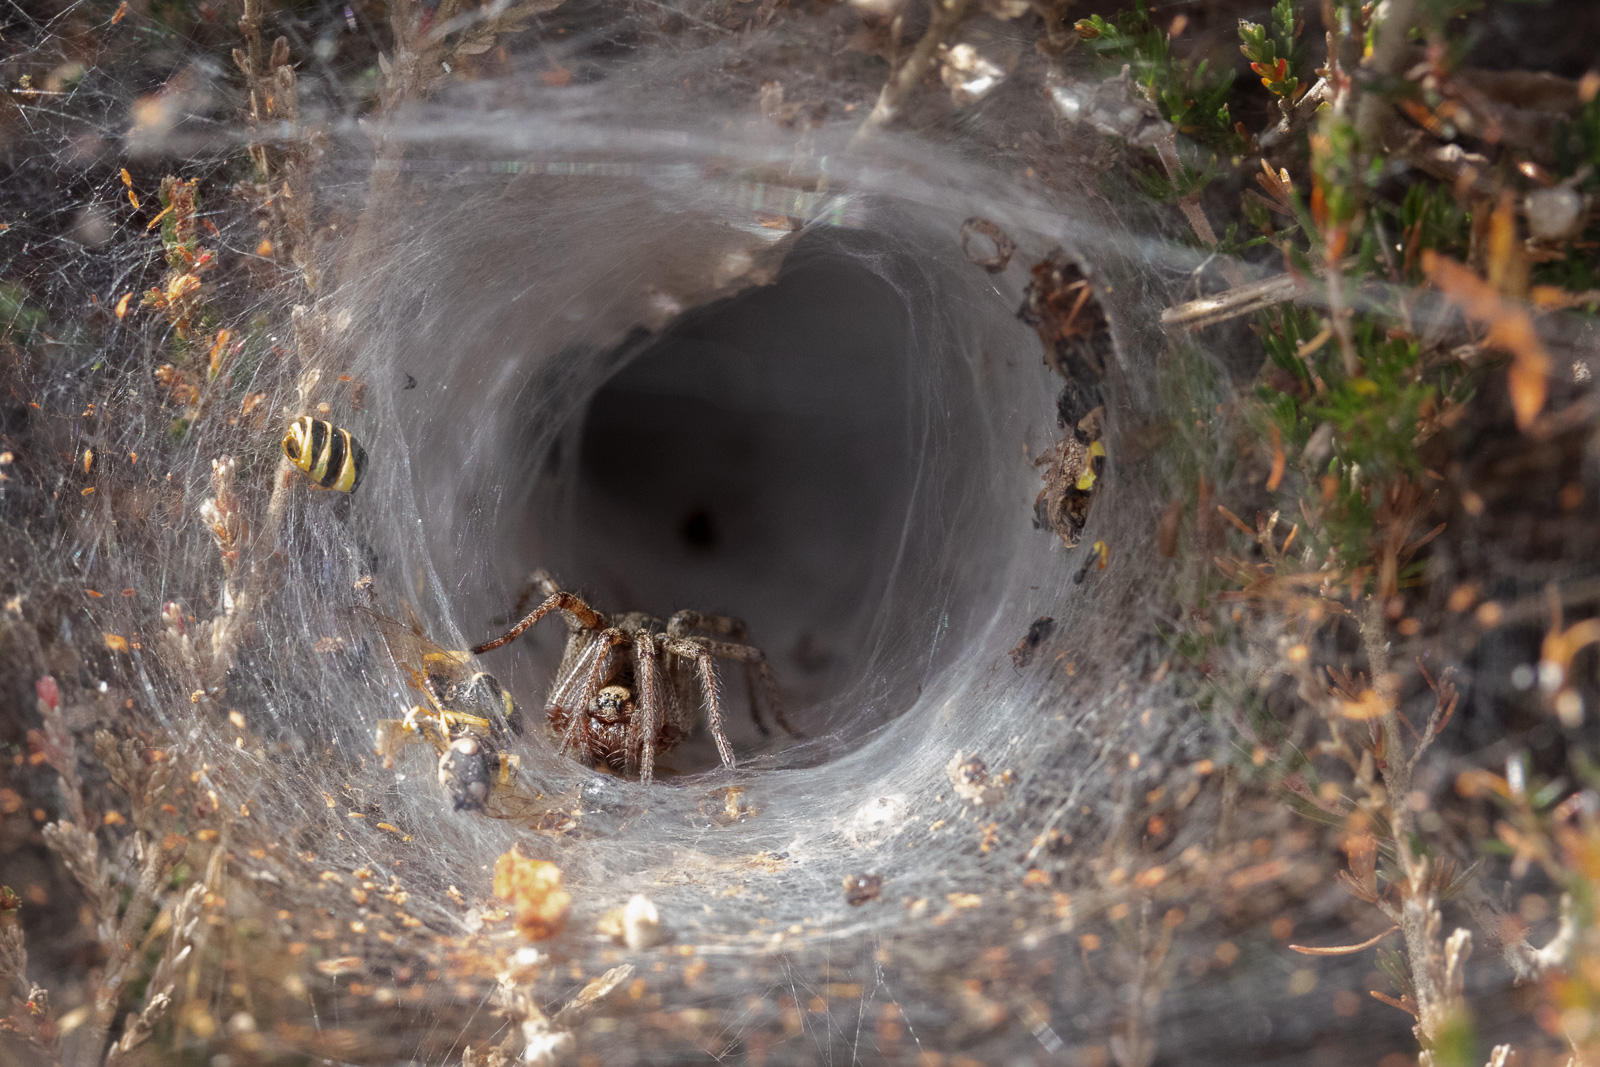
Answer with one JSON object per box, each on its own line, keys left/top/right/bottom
{"left": 363, "top": 613, "right": 522, "bottom": 811}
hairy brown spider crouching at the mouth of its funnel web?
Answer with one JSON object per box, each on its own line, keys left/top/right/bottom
{"left": 472, "top": 571, "right": 800, "bottom": 785}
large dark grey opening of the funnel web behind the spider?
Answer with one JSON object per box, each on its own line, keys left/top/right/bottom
{"left": 536, "top": 240, "right": 917, "bottom": 771}
